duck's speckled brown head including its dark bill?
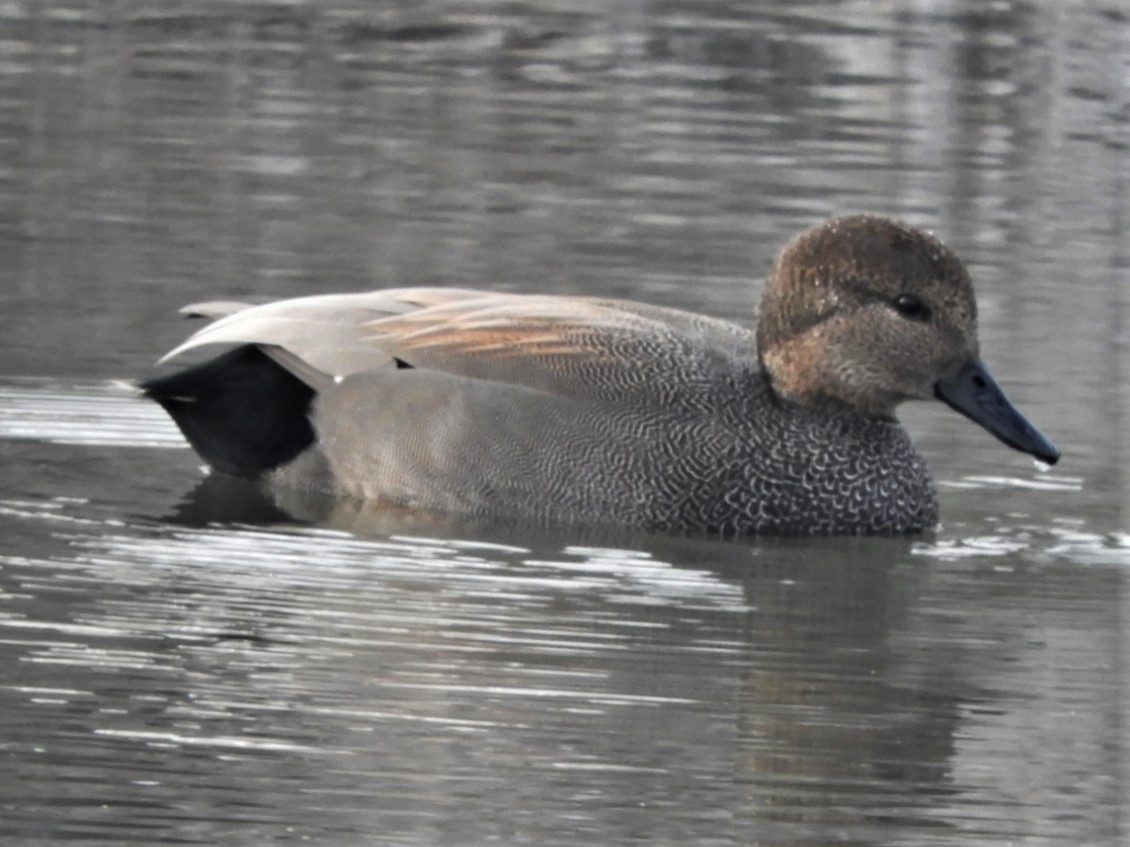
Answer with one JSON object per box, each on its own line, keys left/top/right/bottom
{"left": 757, "top": 215, "right": 1059, "bottom": 463}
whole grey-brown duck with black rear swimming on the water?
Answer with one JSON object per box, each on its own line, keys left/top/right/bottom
{"left": 142, "top": 216, "right": 1059, "bottom": 535}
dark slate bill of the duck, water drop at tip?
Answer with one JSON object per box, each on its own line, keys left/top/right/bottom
{"left": 933, "top": 359, "right": 1060, "bottom": 464}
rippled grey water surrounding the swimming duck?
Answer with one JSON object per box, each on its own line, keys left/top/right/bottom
{"left": 0, "top": 0, "right": 1130, "bottom": 847}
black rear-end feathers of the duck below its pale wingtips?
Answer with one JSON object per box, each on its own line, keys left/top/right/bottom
{"left": 141, "top": 344, "right": 314, "bottom": 479}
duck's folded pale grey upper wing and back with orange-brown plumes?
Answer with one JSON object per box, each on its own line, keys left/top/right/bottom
{"left": 154, "top": 288, "right": 753, "bottom": 402}
